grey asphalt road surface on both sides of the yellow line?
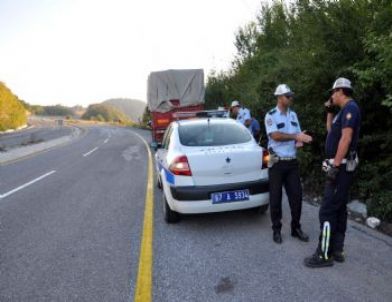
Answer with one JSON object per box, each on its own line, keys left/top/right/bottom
{"left": 0, "top": 127, "right": 392, "bottom": 302}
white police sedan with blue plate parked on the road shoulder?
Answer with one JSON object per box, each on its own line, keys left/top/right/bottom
{"left": 155, "top": 118, "right": 269, "bottom": 223}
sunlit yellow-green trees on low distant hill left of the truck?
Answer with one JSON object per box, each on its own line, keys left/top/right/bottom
{"left": 82, "top": 104, "right": 129, "bottom": 123}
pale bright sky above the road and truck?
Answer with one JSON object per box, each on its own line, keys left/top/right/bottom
{"left": 0, "top": 0, "right": 263, "bottom": 106}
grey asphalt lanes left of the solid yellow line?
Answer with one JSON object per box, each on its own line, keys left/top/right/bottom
{"left": 0, "top": 128, "right": 147, "bottom": 301}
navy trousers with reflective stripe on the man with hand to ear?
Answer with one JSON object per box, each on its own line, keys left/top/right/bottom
{"left": 319, "top": 165, "right": 353, "bottom": 255}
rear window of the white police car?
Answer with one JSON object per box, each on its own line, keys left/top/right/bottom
{"left": 178, "top": 121, "right": 252, "bottom": 146}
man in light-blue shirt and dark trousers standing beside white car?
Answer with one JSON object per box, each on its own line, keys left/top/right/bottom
{"left": 264, "top": 84, "right": 312, "bottom": 243}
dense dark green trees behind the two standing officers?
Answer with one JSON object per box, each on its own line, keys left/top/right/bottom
{"left": 206, "top": 0, "right": 392, "bottom": 221}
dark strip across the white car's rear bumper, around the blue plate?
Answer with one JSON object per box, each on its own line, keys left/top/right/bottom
{"left": 170, "top": 180, "right": 269, "bottom": 201}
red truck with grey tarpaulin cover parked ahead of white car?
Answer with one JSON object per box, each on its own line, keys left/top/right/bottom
{"left": 147, "top": 69, "right": 205, "bottom": 145}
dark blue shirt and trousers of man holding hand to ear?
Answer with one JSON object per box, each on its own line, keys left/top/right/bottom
{"left": 319, "top": 100, "right": 361, "bottom": 255}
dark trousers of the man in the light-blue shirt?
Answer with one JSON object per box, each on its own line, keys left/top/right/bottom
{"left": 268, "top": 159, "right": 302, "bottom": 231}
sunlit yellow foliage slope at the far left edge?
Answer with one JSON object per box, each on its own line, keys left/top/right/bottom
{"left": 0, "top": 82, "right": 27, "bottom": 131}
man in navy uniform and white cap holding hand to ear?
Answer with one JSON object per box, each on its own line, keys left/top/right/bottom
{"left": 305, "top": 78, "right": 361, "bottom": 267}
